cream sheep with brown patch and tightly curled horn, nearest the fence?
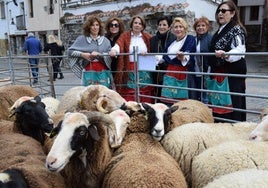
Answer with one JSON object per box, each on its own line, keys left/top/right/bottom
{"left": 57, "top": 85, "right": 126, "bottom": 113}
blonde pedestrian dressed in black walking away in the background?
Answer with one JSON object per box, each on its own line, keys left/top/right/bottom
{"left": 44, "top": 35, "right": 64, "bottom": 81}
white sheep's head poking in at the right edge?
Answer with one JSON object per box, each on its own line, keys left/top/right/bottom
{"left": 249, "top": 115, "right": 268, "bottom": 141}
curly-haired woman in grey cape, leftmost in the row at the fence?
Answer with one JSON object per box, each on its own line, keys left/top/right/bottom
{"left": 68, "top": 16, "right": 112, "bottom": 88}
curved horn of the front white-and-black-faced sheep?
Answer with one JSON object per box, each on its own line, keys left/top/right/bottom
{"left": 82, "top": 111, "right": 120, "bottom": 148}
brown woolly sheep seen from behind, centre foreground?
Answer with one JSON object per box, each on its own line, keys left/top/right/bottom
{"left": 101, "top": 109, "right": 187, "bottom": 188}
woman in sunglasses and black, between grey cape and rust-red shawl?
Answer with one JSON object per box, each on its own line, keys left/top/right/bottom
{"left": 105, "top": 17, "right": 125, "bottom": 73}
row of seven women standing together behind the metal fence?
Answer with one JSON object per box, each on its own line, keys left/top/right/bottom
{"left": 68, "top": 1, "right": 246, "bottom": 121}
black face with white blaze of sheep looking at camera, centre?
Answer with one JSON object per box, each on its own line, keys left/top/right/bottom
{"left": 142, "top": 103, "right": 178, "bottom": 141}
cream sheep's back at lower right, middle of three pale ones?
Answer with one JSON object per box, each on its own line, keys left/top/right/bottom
{"left": 192, "top": 140, "right": 268, "bottom": 188}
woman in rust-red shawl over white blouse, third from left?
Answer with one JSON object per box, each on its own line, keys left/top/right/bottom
{"left": 110, "top": 16, "right": 153, "bottom": 102}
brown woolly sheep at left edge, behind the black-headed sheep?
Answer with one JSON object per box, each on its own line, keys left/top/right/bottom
{"left": 0, "top": 85, "right": 38, "bottom": 120}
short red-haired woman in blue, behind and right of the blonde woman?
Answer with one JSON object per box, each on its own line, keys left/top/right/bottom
{"left": 193, "top": 16, "right": 212, "bottom": 104}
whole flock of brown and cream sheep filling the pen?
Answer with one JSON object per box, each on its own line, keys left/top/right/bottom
{"left": 0, "top": 85, "right": 268, "bottom": 188}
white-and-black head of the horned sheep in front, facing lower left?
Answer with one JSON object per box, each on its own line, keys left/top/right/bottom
{"left": 46, "top": 111, "right": 117, "bottom": 171}
